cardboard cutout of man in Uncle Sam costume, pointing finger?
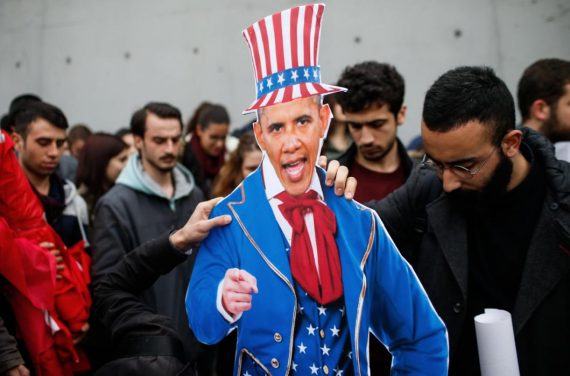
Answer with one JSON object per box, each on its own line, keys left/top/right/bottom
{"left": 186, "top": 4, "right": 447, "bottom": 375}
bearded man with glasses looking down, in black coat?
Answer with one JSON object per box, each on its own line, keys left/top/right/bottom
{"left": 360, "top": 67, "right": 570, "bottom": 375}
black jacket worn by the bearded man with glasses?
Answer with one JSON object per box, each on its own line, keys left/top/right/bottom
{"left": 371, "top": 130, "right": 570, "bottom": 375}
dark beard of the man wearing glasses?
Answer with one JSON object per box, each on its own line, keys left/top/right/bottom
{"left": 446, "top": 151, "right": 513, "bottom": 209}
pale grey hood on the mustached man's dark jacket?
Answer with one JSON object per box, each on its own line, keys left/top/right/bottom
{"left": 116, "top": 154, "right": 195, "bottom": 201}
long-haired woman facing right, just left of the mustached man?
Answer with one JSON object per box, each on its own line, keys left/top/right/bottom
{"left": 75, "top": 133, "right": 129, "bottom": 222}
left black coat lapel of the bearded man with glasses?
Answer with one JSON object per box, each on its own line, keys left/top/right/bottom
{"left": 426, "top": 198, "right": 469, "bottom": 299}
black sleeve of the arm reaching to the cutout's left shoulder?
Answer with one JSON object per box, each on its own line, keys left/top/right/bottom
{"left": 94, "top": 234, "right": 193, "bottom": 375}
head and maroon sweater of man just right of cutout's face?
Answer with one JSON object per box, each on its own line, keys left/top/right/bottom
{"left": 332, "top": 61, "right": 413, "bottom": 202}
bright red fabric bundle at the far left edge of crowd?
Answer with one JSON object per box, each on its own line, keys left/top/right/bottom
{"left": 0, "top": 132, "right": 91, "bottom": 376}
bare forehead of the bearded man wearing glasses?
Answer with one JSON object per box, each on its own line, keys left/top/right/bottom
{"left": 421, "top": 120, "right": 492, "bottom": 162}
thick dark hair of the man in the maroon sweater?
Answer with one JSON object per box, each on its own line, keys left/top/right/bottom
{"left": 338, "top": 61, "right": 405, "bottom": 116}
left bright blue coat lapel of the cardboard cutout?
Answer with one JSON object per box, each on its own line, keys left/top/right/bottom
{"left": 228, "top": 168, "right": 292, "bottom": 286}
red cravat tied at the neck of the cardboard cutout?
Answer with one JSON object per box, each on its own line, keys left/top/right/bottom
{"left": 277, "top": 190, "right": 343, "bottom": 305}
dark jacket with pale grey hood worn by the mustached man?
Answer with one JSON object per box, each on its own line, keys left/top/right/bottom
{"left": 91, "top": 155, "right": 204, "bottom": 360}
